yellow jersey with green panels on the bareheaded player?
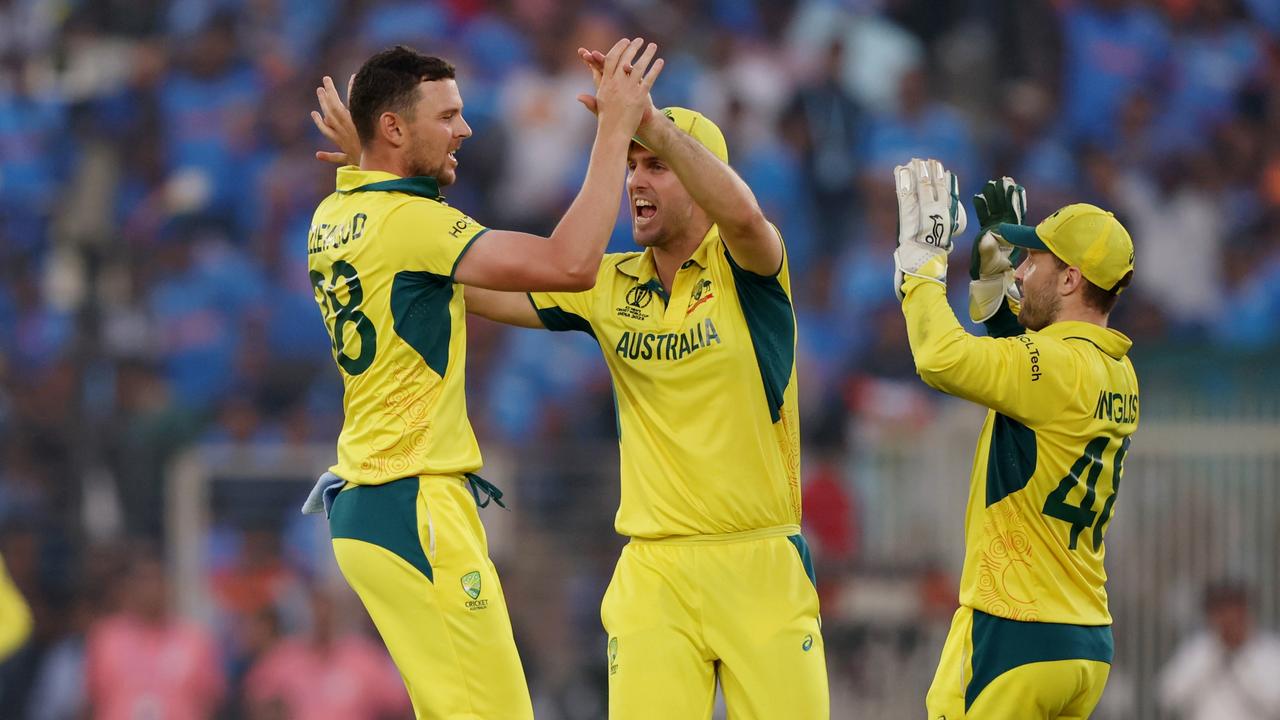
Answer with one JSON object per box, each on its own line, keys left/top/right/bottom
{"left": 307, "top": 165, "right": 485, "bottom": 484}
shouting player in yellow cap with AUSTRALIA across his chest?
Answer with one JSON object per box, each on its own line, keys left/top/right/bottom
{"left": 419, "top": 53, "right": 829, "bottom": 720}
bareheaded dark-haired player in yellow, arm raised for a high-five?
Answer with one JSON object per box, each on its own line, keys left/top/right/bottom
{"left": 305, "top": 38, "right": 662, "bottom": 720}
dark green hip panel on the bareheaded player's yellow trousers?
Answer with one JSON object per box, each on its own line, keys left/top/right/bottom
{"left": 329, "top": 478, "right": 435, "bottom": 582}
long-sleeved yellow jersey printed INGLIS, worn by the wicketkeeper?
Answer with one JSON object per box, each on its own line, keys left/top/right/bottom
{"left": 902, "top": 278, "right": 1138, "bottom": 625}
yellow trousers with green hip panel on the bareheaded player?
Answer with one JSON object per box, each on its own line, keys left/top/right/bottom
{"left": 332, "top": 477, "right": 534, "bottom": 720}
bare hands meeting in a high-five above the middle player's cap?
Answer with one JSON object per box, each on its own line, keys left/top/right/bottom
{"left": 577, "top": 37, "right": 664, "bottom": 137}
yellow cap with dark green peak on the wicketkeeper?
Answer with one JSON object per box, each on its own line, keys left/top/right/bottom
{"left": 997, "top": 202, "right": 1133, "bottom": 293}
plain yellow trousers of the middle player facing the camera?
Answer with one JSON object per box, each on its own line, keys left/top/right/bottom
{"left": 600, "top": 536, "right": 829, "bottom": 720}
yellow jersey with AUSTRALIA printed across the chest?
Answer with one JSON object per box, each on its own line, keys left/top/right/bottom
{"left": 530, "top": 225, "right": 800, "bottom": 538}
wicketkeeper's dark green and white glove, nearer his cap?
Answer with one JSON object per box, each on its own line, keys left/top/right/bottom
{"left": 969, "top": 177, "right": 1027, "bottom": 323}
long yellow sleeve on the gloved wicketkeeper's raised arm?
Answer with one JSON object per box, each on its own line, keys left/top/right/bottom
{"left": 902, "top": 272, "right": 1079, "bottom": 427}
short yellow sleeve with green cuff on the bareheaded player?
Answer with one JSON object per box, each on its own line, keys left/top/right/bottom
{"left": 383, "top": 200, "right": 489, "bottom": 281}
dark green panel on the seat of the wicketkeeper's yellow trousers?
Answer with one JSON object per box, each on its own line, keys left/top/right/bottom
{"left": 964, "top": 610, "right": 1115, "bottom": 710}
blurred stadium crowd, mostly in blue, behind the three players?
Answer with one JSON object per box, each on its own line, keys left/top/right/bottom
{"left": 0, "top": 0, "right": 1280, "bottom": 720}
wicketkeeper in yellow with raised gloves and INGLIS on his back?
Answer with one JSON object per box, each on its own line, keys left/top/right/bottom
{"left": 893, "top": 160, "right": 1138, "bottom": 720}
